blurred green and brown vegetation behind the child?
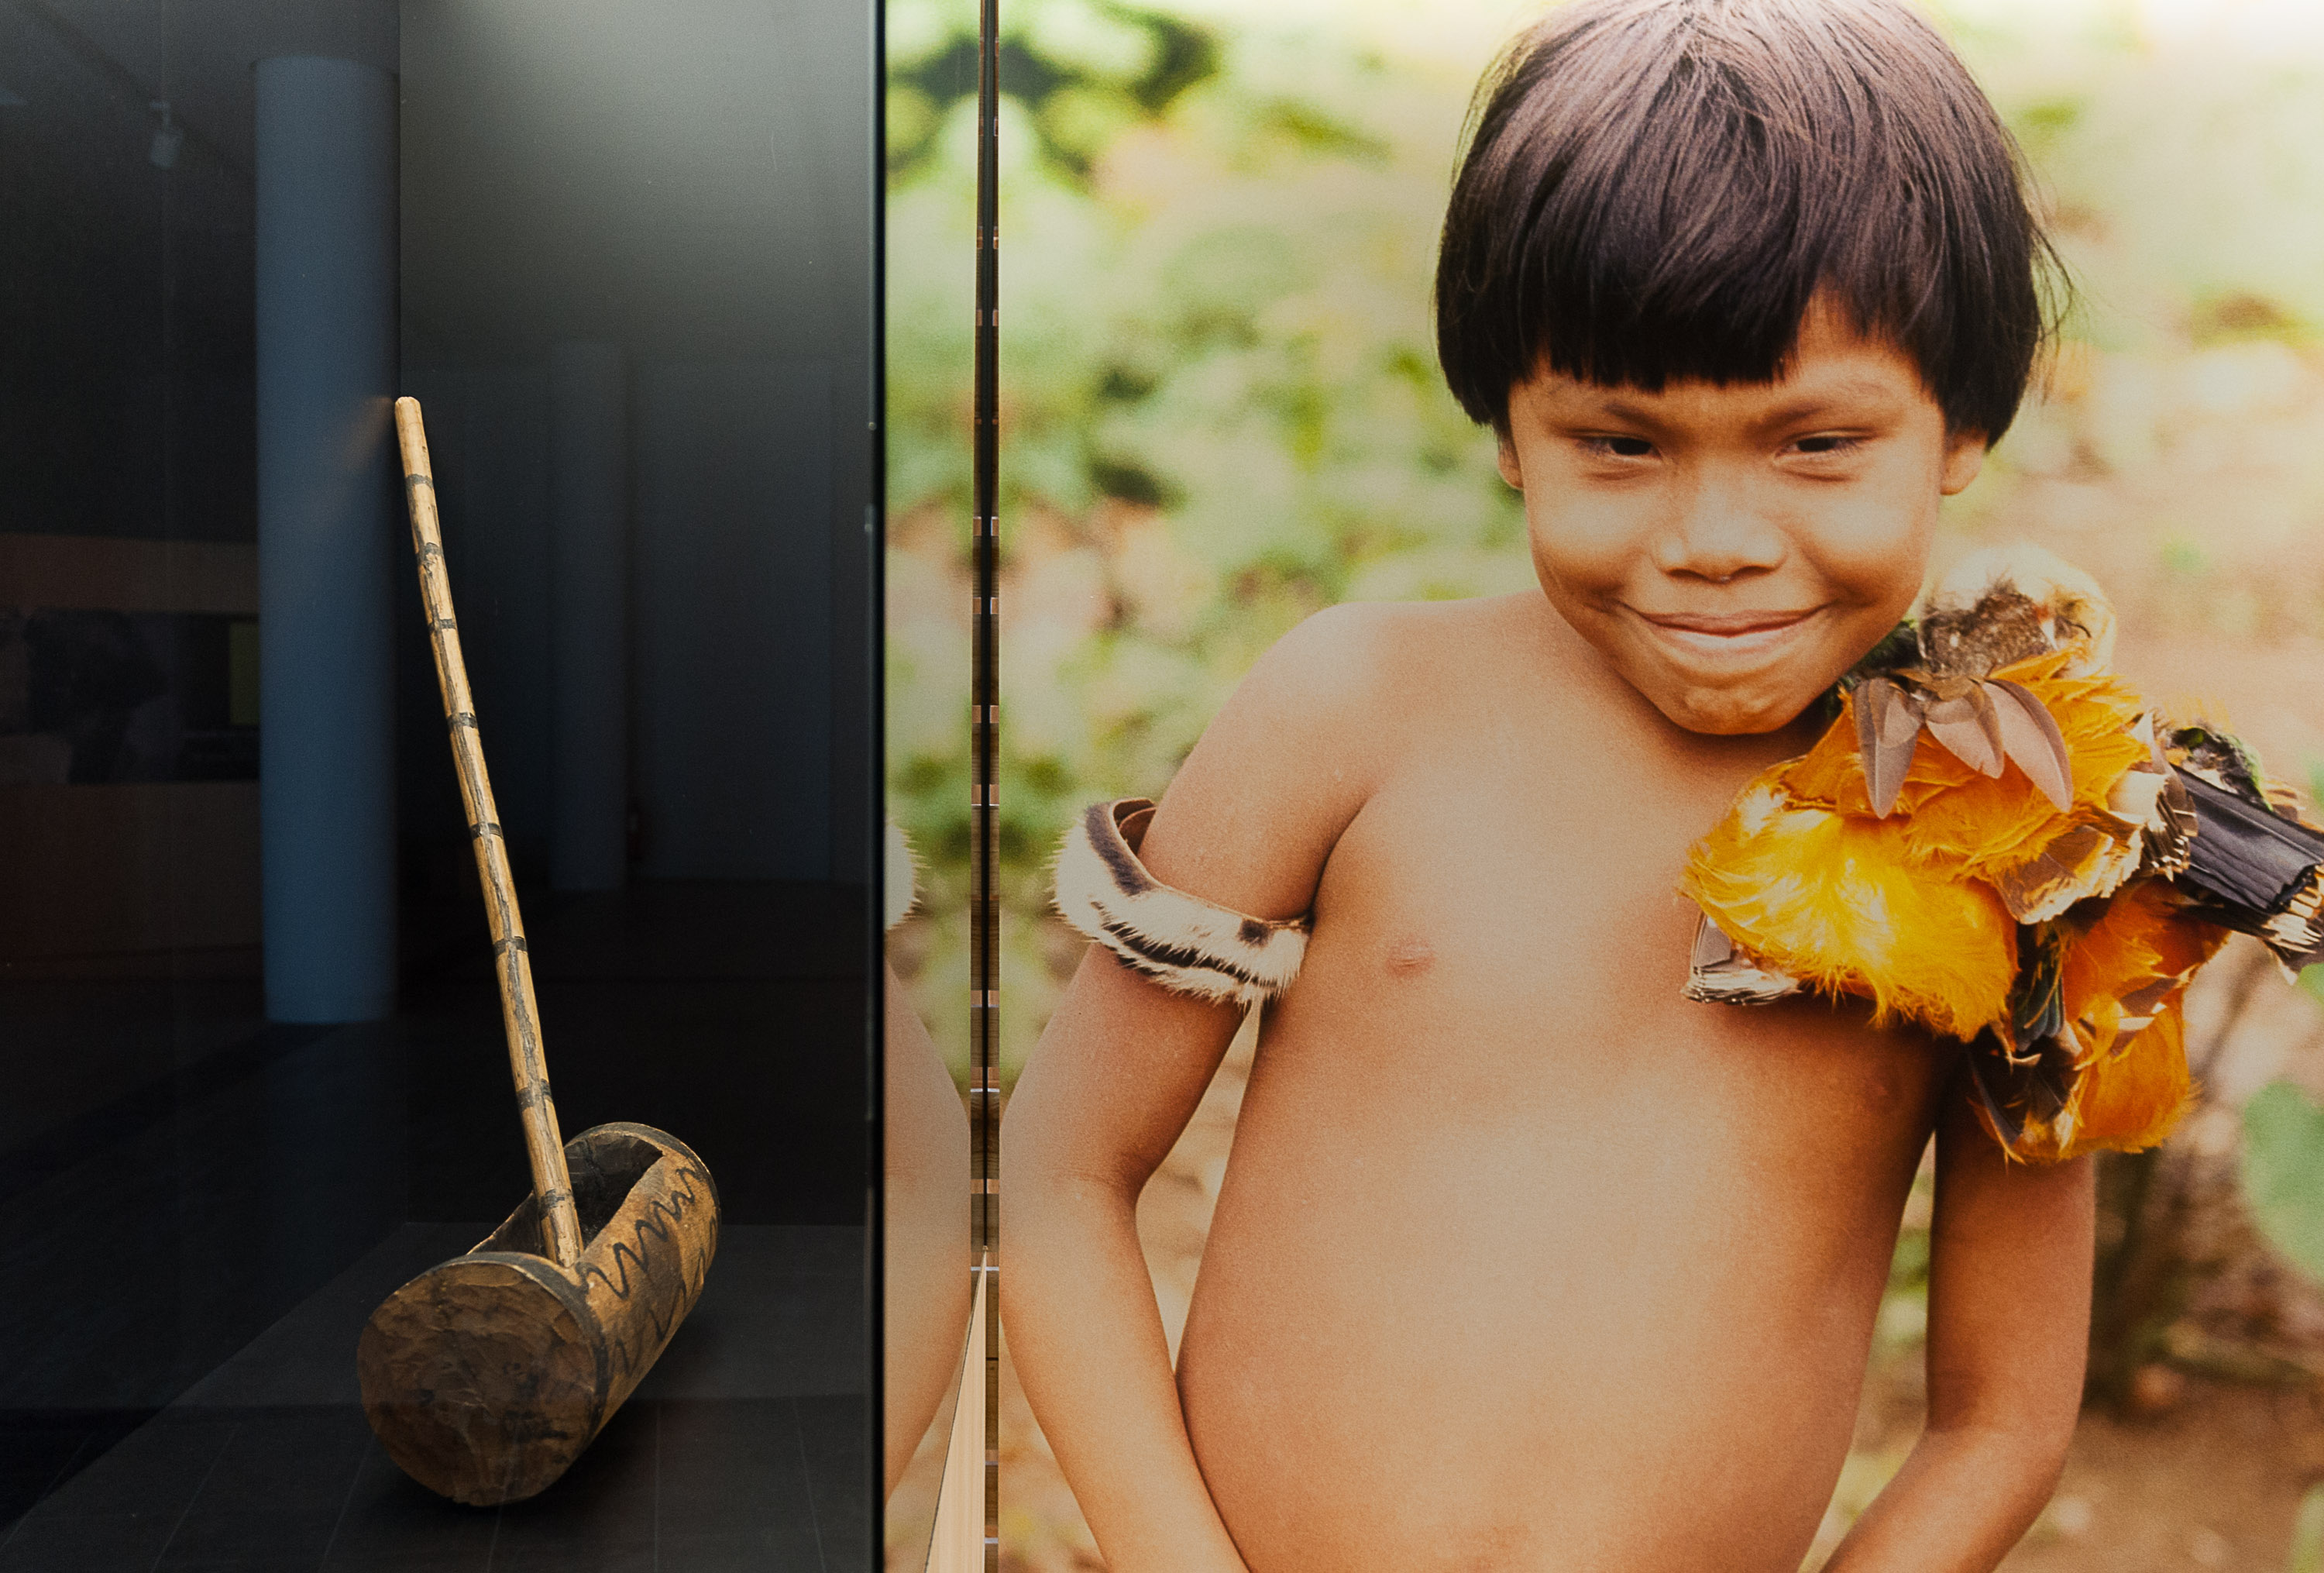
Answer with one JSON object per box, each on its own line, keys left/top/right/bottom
{"left": 888, "top": 0, "right": 2324, "bottom": 1571}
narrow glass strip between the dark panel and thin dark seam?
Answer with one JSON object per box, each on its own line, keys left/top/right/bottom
{"left": 885, "top": 7, "right": 985, "bottom": 1573}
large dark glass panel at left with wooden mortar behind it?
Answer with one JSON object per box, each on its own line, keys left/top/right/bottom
{"left": 0, "top": 0, "right": 881, "bottom": 1568}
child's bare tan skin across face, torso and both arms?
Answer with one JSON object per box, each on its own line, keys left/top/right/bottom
{"left": 1002, "top": 312, "right": 2092, "bottom": 1573}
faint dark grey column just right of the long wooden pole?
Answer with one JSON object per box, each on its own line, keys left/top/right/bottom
{"left": 548, "top": 342, "right": 630, "bottom": 890}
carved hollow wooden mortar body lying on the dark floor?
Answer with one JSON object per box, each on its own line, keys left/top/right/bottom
{"left": 356, "top": 1124, "right": 718, "bottom": 1506}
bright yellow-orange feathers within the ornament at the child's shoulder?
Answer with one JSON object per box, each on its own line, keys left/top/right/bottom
{"left": 1680, "top": 627, "right": 2226, "bottom": 1162}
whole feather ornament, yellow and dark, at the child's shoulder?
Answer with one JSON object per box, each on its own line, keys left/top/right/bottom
{"left": 1680, "top": 549, "right": 2324, "bottom": 1162}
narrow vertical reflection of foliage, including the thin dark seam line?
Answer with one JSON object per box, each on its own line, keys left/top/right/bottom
{"left": 883, "top": 5, "right": 999, "bottom": 1573}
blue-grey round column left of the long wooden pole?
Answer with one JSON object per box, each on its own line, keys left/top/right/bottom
{"left": 256, "top": 56, "right": 409, "bottom": 1022}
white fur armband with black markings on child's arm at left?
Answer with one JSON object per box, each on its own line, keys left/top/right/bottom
{"left": 1057, "top": 797, "right": 1308, "bottom": 1008}
